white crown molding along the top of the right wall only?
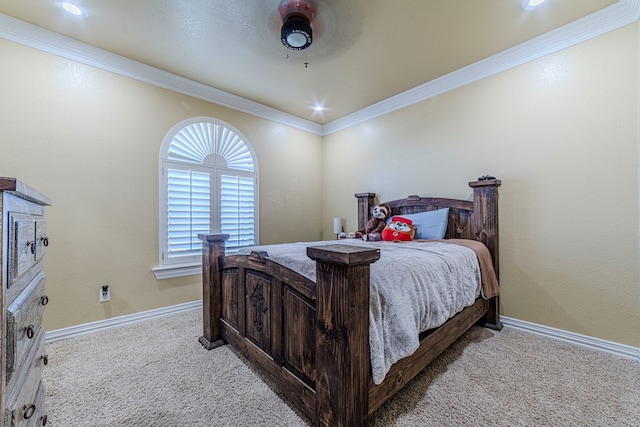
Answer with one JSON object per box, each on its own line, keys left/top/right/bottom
{"left": 323, "top": 0, "right": 640, "bottom": 135}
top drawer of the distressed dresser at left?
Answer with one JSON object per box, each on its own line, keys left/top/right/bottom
{"left": 5, "top": 212, "right": 49, "bottom": 301}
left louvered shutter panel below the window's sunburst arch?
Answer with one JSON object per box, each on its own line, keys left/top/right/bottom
{"left": 166, "top": 168, "right": 211, "bottom": 258}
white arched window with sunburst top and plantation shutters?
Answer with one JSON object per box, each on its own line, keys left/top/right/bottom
{"left": 156, "top": 117, "right": 258, "bottom": 278}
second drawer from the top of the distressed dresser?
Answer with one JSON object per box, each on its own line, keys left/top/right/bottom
{"left": 4, "top": 272, "right": 48, "bottom": 382}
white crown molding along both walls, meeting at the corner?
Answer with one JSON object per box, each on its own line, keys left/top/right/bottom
{"left": 0, "top": 0, "right": 640, "bottom": 136}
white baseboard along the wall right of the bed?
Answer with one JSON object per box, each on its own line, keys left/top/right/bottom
{"left": 500, "top": 316, "right": 640, "bottom": 363}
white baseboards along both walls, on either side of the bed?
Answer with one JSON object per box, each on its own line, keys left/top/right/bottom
{"left": 45, "top": 300, "right": 640, "bottom": 363}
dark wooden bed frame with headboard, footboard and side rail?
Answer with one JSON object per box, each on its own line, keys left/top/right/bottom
{"left": 199, "top": 179, "right": 502, "bottom": 427}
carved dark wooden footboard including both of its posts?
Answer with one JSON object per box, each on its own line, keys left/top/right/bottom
{"left": 200, "top": 234, "right": 380, "bottom": 426}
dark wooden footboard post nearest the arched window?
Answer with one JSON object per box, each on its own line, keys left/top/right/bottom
{"left": 198, "top": 234, "right": 229, "bottom": 350}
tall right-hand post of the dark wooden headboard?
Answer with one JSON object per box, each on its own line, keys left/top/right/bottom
{"left": 469, "top": 179, "right": 502, "bottom": 330}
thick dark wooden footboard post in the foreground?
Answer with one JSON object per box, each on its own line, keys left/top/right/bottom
{"left": 307, "top": 244, "right": 380, "bottom": 427}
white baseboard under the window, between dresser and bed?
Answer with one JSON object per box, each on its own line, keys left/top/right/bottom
{"left": 45, "top": 300, "right": 202, "bottom": 343}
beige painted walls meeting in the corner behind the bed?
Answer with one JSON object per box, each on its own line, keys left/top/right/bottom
{"left": 0, "top": 19, "right": 640, "bottom": 352}
